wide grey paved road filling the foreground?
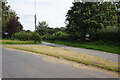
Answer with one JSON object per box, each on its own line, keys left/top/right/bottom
{"left": 2, "top": 48, "right": 116, "bottom": 78}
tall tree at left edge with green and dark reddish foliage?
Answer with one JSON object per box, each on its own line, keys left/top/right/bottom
{"left": 2, "top": 2, "right": 23, "bottom": 38}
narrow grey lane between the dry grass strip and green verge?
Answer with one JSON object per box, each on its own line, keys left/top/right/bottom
{"left": 42, "top": 42, "right": 119, "bottom": 62}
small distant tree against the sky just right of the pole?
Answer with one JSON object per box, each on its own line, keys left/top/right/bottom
{"left": 36, "top": 21, "right": 48, "bottom": 35}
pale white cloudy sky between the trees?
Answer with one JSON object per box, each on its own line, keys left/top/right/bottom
{"left": 7, "top": 0, "right": 73, "bottom": 31}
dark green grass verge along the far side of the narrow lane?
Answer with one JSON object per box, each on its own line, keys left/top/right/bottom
{"left": 45, "top": 40, "right": 120, "bottom": 54}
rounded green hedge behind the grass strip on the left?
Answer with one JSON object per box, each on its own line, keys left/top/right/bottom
{"left": 13, "top": 31, "right": 41, "bottom": 43}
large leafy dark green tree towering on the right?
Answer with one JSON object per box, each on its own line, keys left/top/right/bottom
{"left": 66, "top": 2, "right": 117, "bottom": 39}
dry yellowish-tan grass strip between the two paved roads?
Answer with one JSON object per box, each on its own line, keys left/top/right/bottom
{"left": 5, "top": 45, "right": 120, "bottom": 72}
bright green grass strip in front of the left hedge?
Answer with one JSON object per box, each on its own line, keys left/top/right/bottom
{"left": 0, "top": 40, "right": 41, "bottom": 44}
